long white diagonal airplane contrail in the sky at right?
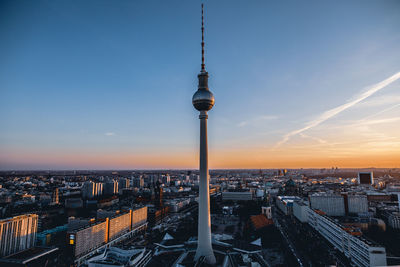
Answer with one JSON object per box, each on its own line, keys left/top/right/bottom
{"left": 275, "top": 72, "right": 400, "bottom": 148}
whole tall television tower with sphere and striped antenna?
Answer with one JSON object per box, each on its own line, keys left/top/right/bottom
{"left": 192, "top": 4, "right": 216, "bottom": 264}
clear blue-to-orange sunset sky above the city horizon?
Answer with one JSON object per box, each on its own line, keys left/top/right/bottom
{"left": 0, "top": 1, "right": 400, "bottom": 169}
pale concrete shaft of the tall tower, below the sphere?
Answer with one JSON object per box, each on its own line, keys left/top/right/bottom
{"left": 195, "top": 111, "right": 216, "bottom": 264}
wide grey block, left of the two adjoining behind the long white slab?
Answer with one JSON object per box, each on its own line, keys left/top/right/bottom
{"left": 310, "top": 194, "right": 346, "bottom": 216}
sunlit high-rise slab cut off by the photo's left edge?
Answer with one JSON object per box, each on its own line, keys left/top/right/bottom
{"left": 0, "top": 214, "right": 38, "bottom": 257}
